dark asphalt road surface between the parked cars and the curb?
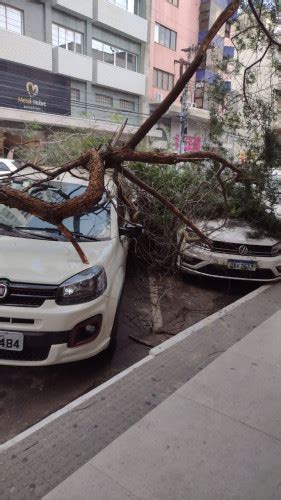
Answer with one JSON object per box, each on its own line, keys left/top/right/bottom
{"left": 0, "top": 268, "right": 252, "bottom": 443}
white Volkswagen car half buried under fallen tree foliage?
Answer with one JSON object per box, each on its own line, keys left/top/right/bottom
{"left": 177, "top": 220, "right": 281, "bottom": 282}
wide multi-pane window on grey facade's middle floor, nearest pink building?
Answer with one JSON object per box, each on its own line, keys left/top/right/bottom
{"left": 92, "top": 39, "right": 137, "bottom": 71}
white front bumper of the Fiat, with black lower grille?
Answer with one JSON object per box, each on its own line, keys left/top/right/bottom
{"left": 0, "top": 295, "right": 116, "bottom": 366}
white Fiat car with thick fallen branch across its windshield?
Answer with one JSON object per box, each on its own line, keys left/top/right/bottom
{"left": 0, "top": 174, "right": 142, "bottom": 366}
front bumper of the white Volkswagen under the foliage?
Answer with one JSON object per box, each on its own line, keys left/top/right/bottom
{"left": 177, "top": 248, "right": 281, "bottom": 283}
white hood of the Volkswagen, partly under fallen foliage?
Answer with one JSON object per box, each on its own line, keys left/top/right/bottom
{"left": 198, "top": 220, "right": 278, "bottom": 246}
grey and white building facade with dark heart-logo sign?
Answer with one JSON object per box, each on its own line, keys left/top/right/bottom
{"left": 0, "top": 0, "right": 153, "bottom": 151}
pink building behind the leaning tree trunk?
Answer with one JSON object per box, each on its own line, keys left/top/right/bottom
{"left": 148, "top": 0, "right": 200, "bottom": 149}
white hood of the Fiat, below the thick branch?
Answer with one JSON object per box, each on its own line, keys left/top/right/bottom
{"left": 0, "top": 235, "right": 113, "bottom": 285}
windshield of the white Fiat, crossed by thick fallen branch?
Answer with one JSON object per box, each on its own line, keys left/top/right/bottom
{"left": 0, "top": 180, "right": 111, "bottom": 240}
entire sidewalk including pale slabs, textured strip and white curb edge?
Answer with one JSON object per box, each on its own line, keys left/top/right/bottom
{"left": 0, "top": 284, "right": 281, "bottom": 500}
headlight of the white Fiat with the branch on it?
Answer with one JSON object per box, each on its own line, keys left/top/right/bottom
{"left": 56, "top": 266, "right": 107, "bottom": 306}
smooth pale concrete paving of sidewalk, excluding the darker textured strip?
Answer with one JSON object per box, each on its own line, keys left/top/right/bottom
{"left": 45, "top": 311, "right": 281, "bottom": 500}
